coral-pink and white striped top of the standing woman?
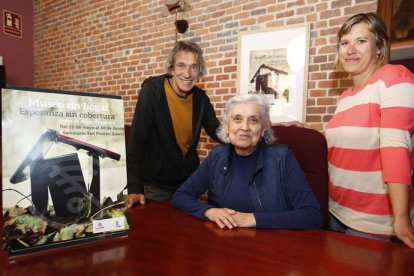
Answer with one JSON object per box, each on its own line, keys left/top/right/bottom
{"left": 326, "top": 65, "right": 414, "bottom": 235}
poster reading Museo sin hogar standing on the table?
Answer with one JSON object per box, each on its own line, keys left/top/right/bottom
{"left": 1, "top": 87, "right": 129, "bottom": 257}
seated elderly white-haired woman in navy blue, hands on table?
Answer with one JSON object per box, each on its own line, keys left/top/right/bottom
{"left": 172, "top": 94, "right": 323, "bottom": 229}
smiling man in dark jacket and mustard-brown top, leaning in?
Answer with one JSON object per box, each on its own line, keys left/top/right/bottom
{"left": 127, "top": 41, "right": 220, "bottom": 208}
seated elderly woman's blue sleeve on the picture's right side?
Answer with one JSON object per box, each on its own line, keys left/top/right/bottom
{"left": 254, "top": 150, "right": 323, "bottom": 229}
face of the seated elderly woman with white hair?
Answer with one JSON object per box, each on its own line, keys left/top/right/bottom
{"left": 228, "top": 103, "right": 265, "bottom": 155}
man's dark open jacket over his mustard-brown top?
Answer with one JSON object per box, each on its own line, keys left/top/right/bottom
{"left": 127, "top": 75, "right": 220, "bottom": 194}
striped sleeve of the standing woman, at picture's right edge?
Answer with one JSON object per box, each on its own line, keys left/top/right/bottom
{"left": 380, "top": 66, "right": 414, "bottom": 184}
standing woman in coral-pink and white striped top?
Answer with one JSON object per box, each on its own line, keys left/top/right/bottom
{"left": 326, "top": 13, "right": 414, "bottom": 249}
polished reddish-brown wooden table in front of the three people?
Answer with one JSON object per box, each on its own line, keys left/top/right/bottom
{"left": 0, "top": 202, "right": 414, "bottom": 276}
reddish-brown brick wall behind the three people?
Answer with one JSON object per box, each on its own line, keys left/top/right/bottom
{"left": 34, "top": 0, "right": 377, "bottom": 156}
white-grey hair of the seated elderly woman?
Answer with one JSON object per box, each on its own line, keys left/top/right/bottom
{"left": 217, "top": 94, "right": 275, "bottom": 144}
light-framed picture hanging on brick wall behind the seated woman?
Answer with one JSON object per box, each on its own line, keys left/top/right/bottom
{"left": 237, "top": 24, "right": 309, "bottom": 122}
